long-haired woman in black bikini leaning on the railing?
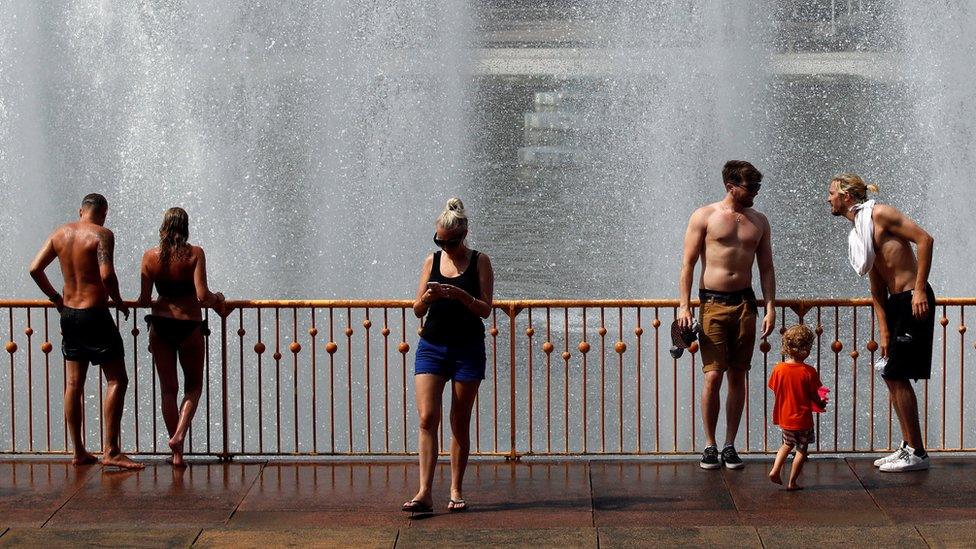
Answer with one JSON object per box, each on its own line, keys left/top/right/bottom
{"left": 139, "top": 208, "right": 224, "bottom": 467}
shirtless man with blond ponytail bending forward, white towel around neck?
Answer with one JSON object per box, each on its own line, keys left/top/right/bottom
{"left": 827, "top": 173, "right": 935, "bottom": 473}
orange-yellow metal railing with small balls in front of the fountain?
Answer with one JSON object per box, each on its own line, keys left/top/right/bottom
{"left": 0, "top": 298, "right": 976, "bottom": 458}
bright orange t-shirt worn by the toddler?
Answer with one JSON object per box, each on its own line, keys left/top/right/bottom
{"left": 769, "top": 362, "right": 823, "bottom": 431}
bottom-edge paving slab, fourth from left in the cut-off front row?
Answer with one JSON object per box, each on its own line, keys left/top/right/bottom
{"left": 598, "top": 526, "right": 762, "bottom": 549}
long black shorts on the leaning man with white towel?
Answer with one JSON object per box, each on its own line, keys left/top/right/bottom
{"left": 881, "top": 285, "right": 935, "bottom": 380}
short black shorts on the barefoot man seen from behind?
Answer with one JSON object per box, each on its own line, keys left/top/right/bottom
{"left": 61, "top": 307, "right": 124, "bottom": 364}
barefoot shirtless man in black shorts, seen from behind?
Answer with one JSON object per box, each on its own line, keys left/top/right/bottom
{"left": 30, "top": 193, "right": 144, "bottom": 469}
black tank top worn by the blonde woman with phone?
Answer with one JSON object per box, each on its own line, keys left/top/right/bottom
{"left": 421, "top": 250, "right": 485, "bottom": 345}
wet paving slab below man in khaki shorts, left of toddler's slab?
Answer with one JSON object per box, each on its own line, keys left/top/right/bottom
{"left": 590, "top": 461, "right": 739, "bottom": 526}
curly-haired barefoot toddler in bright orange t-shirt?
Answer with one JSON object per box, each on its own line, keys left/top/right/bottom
{"left": 769, "top": 324, "right": 827, "bottom": 490}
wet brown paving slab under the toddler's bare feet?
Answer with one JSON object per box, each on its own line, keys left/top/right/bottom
{"left": 722, "top": 457, "right": 890, "bottom": 526}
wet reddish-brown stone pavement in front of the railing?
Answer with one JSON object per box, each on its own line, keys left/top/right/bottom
{"left": 0, "top": 455, "right": 976, "bottom": 549}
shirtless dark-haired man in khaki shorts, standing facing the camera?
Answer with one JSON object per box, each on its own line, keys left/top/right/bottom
{"left": 678, "top": 160, "right": 776, "bottom": 469}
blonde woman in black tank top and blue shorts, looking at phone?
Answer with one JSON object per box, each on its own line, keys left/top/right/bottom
{"left": 402, "top": 198, "right": 495, "bottom": 513}
